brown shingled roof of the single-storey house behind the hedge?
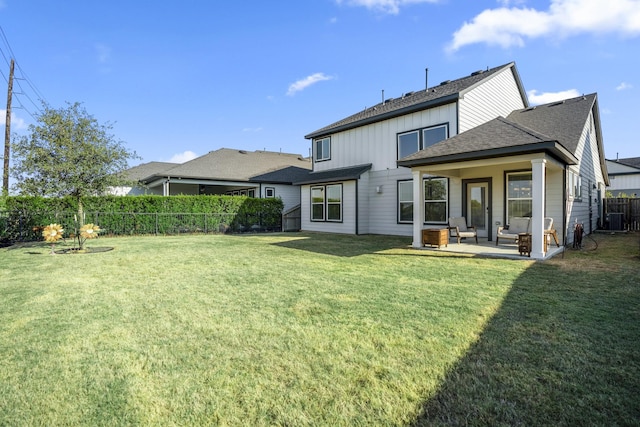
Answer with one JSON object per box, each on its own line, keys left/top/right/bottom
{"left": 142, "top": 148, "right": 311, "bottom": 182}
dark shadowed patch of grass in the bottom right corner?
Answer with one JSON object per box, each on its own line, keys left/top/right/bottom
{"left": 411, "top": 234, "right": 640, "bottom": 426}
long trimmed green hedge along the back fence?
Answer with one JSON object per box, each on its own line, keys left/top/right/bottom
{"left": 0, "top": 196, "right": 283, "bottom": 241}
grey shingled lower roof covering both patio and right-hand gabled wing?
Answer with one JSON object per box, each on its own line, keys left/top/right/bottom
{"left": 398, "top": 94, "right": 606, "bottom": 170}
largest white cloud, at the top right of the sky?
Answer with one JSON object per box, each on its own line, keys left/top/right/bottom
{"left": 448, "top": 0, "right": 640, "bottom": 51}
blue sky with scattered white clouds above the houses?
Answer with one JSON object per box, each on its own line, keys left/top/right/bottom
{"left": 0, "top": 0, "right": 640, "bottom": 165}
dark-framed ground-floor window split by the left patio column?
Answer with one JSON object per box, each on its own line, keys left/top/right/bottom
{"left": 398, "top": 178, "right": 449, "bottom": 223}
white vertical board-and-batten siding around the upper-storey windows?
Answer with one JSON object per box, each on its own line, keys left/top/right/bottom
{"left": 313, "top": 103, "right": 458, "bottom": 175}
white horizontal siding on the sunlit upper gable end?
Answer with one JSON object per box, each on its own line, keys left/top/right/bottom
{"left": 459, "top": 68, "right": 525, "bottom": 133}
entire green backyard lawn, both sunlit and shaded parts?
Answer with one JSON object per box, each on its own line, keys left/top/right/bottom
{"left": 0, "top": 234, "right": 640, "bottom": 426}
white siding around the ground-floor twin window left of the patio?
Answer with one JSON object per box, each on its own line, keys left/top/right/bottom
{"left": 300, "top": 181, "right": 357, "bottom": 234}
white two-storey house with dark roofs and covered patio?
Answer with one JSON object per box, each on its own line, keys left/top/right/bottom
{"left": 298, "top": 63, "right": 608, "bottom": 258}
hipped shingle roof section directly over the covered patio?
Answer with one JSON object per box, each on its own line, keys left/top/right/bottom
{"left": 398, "top": 117, "right": 577, "bottom": 167}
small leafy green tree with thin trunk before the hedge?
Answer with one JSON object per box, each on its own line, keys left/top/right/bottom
{"left": 12, "top": 102, "right": 138, "bottom": 249}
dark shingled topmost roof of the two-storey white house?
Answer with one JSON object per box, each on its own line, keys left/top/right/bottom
{"left": 305, "top": 62, "right": 529, "bottom": 139}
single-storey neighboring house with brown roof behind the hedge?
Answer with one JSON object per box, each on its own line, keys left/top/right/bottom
{"left": 114, "top": 148, "right": 311, "bottom": 209}
